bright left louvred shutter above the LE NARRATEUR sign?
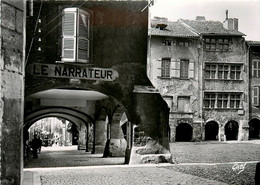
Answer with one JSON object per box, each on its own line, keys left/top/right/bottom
{"left": 62, "top": 8, "right": 77, "bottom": 62}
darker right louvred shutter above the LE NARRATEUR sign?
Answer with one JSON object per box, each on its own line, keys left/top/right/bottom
{"left": 77, "top": 10, "right": 90, "bottom": 62}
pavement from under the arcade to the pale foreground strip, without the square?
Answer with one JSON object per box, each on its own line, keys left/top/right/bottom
{"left": 25, "top": 146, "right": 228, "bottom": 185}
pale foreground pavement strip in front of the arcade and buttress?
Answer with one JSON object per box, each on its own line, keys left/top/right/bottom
{"left": 28, "top": 165, "right": 225, "bottom": 185}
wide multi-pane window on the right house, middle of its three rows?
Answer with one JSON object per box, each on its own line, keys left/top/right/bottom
{"left": 205, "top": 63, "right": 242, "bottom": 80}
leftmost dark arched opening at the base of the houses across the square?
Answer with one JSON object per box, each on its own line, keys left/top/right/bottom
{"left": 176, "top": 123, "right": 192, "bottom": 141}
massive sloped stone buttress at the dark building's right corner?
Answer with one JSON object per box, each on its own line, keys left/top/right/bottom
{"left": 129, "top": 90, "right": 172, "bottom": 164}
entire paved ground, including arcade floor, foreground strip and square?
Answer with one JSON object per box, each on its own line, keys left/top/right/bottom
{"left": 24, "top": 142, "right": 260, "bottom": 185}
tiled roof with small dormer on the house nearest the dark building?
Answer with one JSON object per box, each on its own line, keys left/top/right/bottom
{"left": 148, "top": 20, "right": 199, "bottom": 37}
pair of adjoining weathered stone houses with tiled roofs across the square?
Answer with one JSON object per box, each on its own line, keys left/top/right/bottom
{"left": 147, "top": 16, "right": 249, "bottom": 142}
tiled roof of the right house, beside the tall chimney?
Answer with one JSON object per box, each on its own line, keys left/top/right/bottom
{"left": 179, "top": 19, "right": 245, "bottom": 36}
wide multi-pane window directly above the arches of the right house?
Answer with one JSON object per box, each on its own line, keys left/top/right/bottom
{"left": 204, "top": 92, "right": 242, "bottom": 109}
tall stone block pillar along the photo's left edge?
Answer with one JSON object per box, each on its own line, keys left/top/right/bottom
{"left": 0, "top": 0, "right": 25, "bottom": 185}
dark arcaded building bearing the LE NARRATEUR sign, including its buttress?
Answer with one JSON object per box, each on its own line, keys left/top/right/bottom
{"left": 24, "top": 0, "right": 171, "bottom": 166}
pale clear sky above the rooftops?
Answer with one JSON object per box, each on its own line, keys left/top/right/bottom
{"left": 150, "top": 0, "right": 260, "bottom": 41}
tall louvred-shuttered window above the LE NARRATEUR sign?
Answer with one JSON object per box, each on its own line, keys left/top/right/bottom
{"left": 62, "top": 8, "right": 90, "bottom": 63}
